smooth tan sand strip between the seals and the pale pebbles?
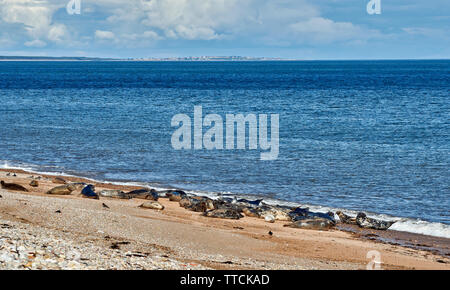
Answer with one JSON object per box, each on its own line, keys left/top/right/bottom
{"left": 0, "top": 169, "right": 450, "bottom": 269}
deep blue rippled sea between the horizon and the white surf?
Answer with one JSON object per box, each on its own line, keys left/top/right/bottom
{"left": 0, "top": 60, "right": 450, "bottom": 233}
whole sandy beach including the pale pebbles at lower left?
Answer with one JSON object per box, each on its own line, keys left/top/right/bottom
{"left": 0, "top": 170, "right": 450, "bottom": 270}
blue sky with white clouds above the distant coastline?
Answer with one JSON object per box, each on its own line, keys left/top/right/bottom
{"left": 0, "top": 0, "right": 450, "bottom": 59}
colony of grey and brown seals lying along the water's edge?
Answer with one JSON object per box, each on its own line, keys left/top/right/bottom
{"left": 1, "top": 173, "right": 395, "bottom": 230}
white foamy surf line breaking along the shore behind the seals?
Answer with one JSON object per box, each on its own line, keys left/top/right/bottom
{"left": 0, "top": 160, "right": 450, "bottom": 239}
